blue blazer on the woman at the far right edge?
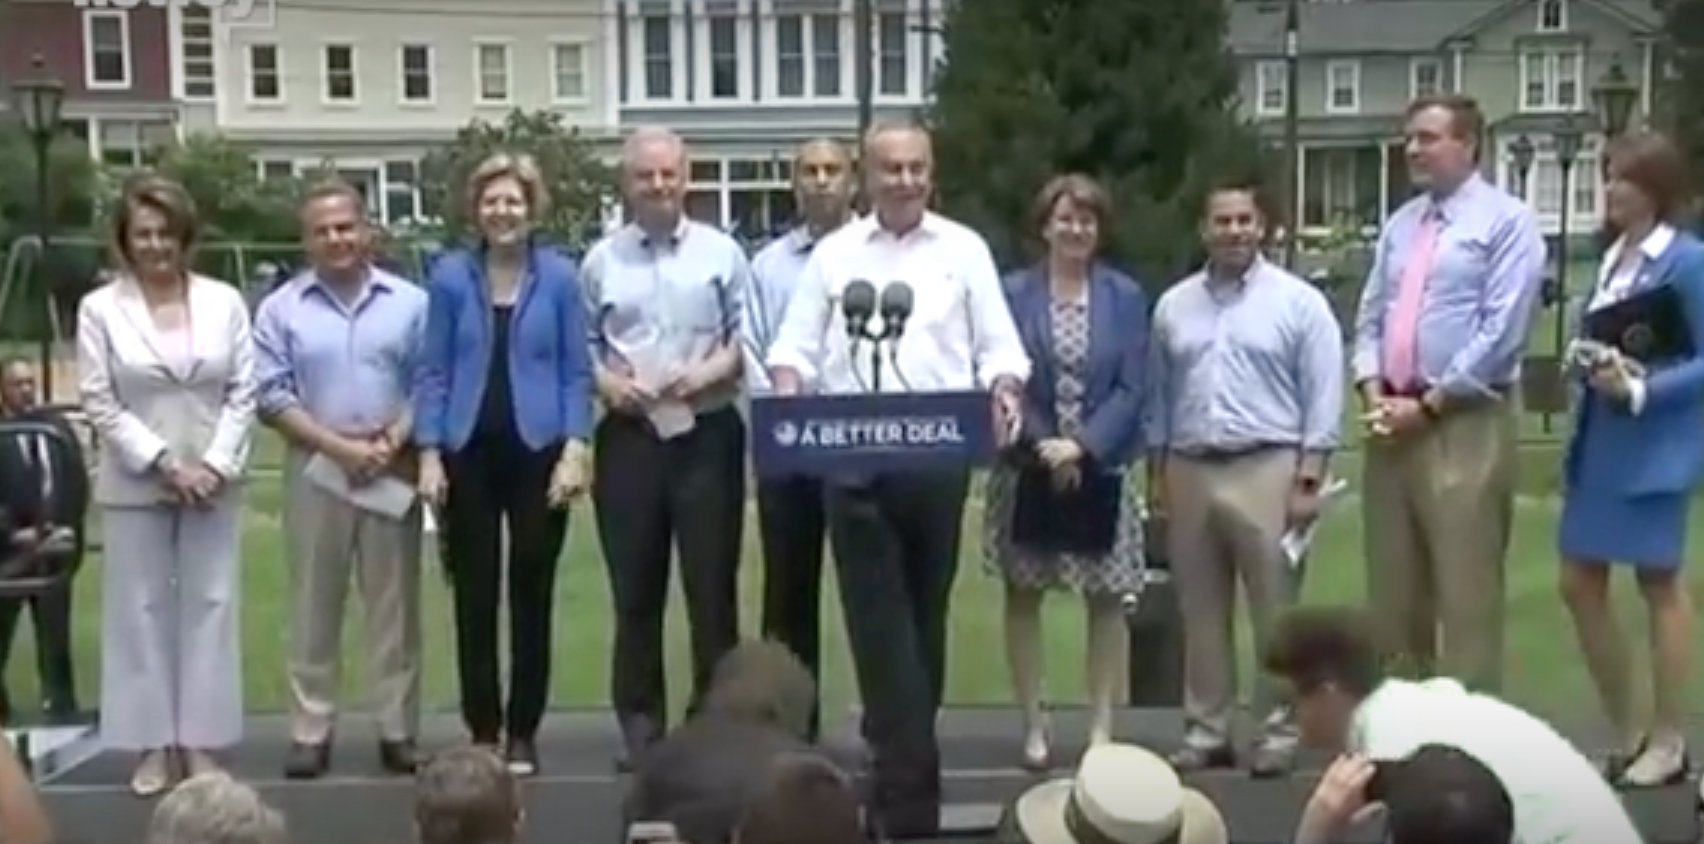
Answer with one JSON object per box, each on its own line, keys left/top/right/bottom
{"left": 1563, "top": 232, "right": 1704, "bottom": 498}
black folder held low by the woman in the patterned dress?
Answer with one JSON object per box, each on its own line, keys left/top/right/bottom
{"left": 1010, "top": 462, "right": 1125, "bottom": 556}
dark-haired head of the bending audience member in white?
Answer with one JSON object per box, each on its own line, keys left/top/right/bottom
{"left": 1261, "top": 607, "right": 1384, "bottom": 749}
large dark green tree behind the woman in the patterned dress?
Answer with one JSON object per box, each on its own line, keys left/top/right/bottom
{"left": 930, "top": 0, "right": 1261, "bottom": 285}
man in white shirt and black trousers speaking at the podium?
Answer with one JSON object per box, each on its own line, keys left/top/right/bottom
{"left": 767, "top": 124, "right": 1029, "bottom": 839}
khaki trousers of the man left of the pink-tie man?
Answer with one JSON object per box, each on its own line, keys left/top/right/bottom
{"left": 1166, "top": 448, "right": 1300, "bottom": 747}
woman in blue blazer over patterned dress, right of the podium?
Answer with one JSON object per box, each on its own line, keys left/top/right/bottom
{"left": 983, "top": 176, "right": 1148, "bottom": 769}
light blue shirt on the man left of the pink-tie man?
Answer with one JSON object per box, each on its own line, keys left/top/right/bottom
{"left": 1148, "top": 261, "right": 1343, "bottom": 452}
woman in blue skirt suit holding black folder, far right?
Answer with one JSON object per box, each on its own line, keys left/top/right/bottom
{"left": 1559, "top": 133, "right": 1704, "bottom": 786}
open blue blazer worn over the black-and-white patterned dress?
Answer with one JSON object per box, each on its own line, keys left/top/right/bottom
{"left": 1005, "top": 264, "right": 1148, "bottom": 469}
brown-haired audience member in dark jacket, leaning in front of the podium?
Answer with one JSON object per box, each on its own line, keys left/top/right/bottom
{"left": 624, "top": 643, "right": 834, "bottom": 844}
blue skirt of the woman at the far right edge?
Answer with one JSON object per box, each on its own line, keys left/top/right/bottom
{"left": 1557, "top": 426, "right": 1692, "bottom": 571}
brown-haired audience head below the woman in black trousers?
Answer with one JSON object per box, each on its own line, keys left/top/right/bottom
{"left": 414, "top": 747, "right": 521, "bottom": 844}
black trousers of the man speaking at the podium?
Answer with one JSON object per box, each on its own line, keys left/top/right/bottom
{"left": 825, "top": 471, "right": 970, "bottom": 837}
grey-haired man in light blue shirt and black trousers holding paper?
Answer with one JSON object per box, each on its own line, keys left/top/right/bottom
{"left": 581, "top": 128, "right": 750, "bottom": 766}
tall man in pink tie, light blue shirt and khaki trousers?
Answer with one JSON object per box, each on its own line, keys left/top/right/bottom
{"left": 1353, "top": 94, "right": 1544, "bottom": 691}
